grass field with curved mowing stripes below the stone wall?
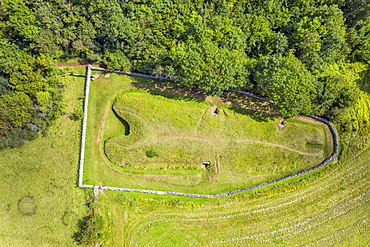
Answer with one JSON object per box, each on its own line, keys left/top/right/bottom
{"left": 99, "top": 139, "right": 370, "bottom": 246}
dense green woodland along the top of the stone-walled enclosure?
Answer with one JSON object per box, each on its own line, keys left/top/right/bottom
{"left": 0, "top": 0, "right": 370, "bottom": 148}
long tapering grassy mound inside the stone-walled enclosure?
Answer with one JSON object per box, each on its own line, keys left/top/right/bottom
{"left": 99, "top": 89, "right": 329, "bottom": 193}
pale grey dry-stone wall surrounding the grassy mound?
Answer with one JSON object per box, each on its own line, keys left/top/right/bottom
{"left": 78, "top": 65, "right": 339, "bottom": 198}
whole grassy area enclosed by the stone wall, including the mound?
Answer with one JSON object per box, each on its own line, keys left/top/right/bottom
{"left": 84, "top": 74, "right": 330, "bottom": 194}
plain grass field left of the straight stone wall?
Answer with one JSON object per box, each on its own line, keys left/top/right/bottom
{"left": 0, "top": 66, "right": 86, "bottom": 247}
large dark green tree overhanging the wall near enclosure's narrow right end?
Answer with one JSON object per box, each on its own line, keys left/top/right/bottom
{"left": 254, "top": 54, "right": 315, "bottom": 117}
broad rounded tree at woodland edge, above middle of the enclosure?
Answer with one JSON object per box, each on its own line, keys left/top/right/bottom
{"left": 170, "top": 41, "right": 251, "bottom": 95}
